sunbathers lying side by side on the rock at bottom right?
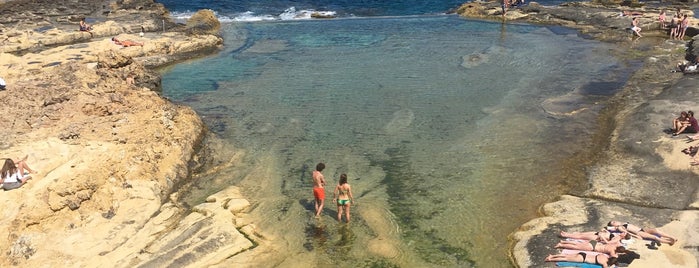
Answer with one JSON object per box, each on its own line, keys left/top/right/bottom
{"left": 544, "top": 220, "right": 677, "bottom": 268}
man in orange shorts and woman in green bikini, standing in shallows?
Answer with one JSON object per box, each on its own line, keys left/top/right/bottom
{"left": 311, "top": 163, "right": 354, "bottom": 222}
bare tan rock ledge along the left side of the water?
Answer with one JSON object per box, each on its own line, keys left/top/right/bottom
{"left": 0, "top": 0, "right": 265, "bottom": 267}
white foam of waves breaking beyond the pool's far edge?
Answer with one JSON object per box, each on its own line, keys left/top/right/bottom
{"left": 170, "top": 7, "right": 337, "bottom": 22}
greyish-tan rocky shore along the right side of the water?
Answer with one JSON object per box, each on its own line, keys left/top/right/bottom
{"left": 457, "top": 2, "right": 699, "bottom": 267}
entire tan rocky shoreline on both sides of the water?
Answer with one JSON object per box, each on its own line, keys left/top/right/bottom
{"left": 0, "top": 0, "right": 699, "bottom": 267}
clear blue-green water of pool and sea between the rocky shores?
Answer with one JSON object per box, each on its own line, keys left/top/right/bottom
{"left": 153, "top": 0, "right": 635, "bottom": 267}
